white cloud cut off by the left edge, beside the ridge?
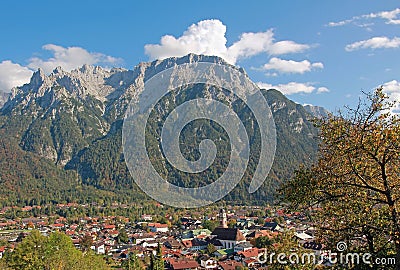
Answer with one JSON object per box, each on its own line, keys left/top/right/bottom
{"left": 0, "top": 60, "right": 33, "bottom": 92}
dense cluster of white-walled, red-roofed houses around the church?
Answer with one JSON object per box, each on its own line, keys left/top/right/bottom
{"left": 0, "top": 209, "right": 322, "bottom": 270}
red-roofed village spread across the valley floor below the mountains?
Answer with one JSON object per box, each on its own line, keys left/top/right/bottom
{"left": 0, "top": 203, "right": 323, "bottom": 270}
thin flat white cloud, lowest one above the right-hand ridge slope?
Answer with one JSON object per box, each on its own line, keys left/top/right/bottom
{"left": 257, "top": 82, "right": 329, "bottom": 95}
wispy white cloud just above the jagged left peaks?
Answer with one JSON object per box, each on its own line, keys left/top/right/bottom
{"left": 28, "top": 44, "right": 121, "bottom": 73}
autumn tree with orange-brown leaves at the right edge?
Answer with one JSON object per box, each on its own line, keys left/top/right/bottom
{"left": 281, "top": 88, "right": 400, "bottom": 269}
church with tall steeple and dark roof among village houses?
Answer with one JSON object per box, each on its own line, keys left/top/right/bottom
{"left": 211, "top": 209, "right": 246, "bottom": 248}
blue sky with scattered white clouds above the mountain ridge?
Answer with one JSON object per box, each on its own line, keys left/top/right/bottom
{"left": 0, "top": 0, "right": 400, "bottom": 110}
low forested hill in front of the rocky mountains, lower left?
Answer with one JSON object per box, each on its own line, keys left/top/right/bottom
{"left": 0, "top": 130, "right": 120, "bottom": 206}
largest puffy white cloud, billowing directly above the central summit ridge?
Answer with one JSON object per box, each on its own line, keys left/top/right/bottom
{"left": 144, "top": 20, "right": 310, "bottom": 64}
